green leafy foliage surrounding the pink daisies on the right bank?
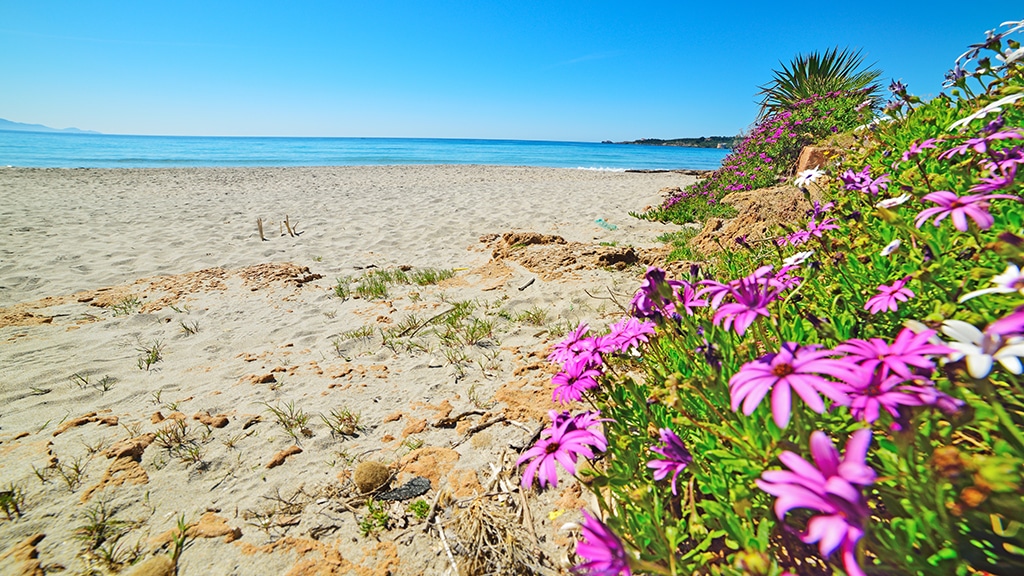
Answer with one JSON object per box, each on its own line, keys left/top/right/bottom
{"left": 536, "top": 21, "right": 1024, "bottom": 576}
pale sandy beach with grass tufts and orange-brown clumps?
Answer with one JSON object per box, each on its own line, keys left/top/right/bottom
{"left": 0, "top": 166, "right": 694, "bottom": 575}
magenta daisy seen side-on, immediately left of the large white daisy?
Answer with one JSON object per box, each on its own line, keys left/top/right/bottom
{"left": 836, "top": 328, "right": 953, "bottom": 380}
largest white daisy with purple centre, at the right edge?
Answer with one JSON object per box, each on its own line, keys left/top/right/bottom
{"left": 942, "top": 320, "right": 1024, "bottom": 378}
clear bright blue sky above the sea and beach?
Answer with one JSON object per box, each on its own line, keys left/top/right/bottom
{"left": 0, "top": 0, "right": 1024, "bottom": 141}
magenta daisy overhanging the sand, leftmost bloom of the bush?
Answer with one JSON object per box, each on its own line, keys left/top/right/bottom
{"left": 516, "top": 410, "right": 608, "bottom": 488}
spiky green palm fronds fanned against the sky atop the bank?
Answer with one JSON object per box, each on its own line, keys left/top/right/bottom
{"left": 758, "top": 47, "right": 882, "bottom": 120}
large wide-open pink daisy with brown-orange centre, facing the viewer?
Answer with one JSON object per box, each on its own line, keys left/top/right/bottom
{"left": 729, "top": 342, "right": 852, "bottom": 428}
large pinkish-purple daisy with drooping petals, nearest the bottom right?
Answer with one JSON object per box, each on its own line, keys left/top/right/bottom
{"left": 757, "top": 428, "right": 876, "bottom": 576}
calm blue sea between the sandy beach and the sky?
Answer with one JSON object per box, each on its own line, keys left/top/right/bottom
{"left": 0, "top": 130, "right": 729, "bottom": 170}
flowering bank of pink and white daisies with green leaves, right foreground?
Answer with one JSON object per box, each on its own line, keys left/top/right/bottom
{"left": 532, "top": 22, "right": 1024, "bottom": 576}
